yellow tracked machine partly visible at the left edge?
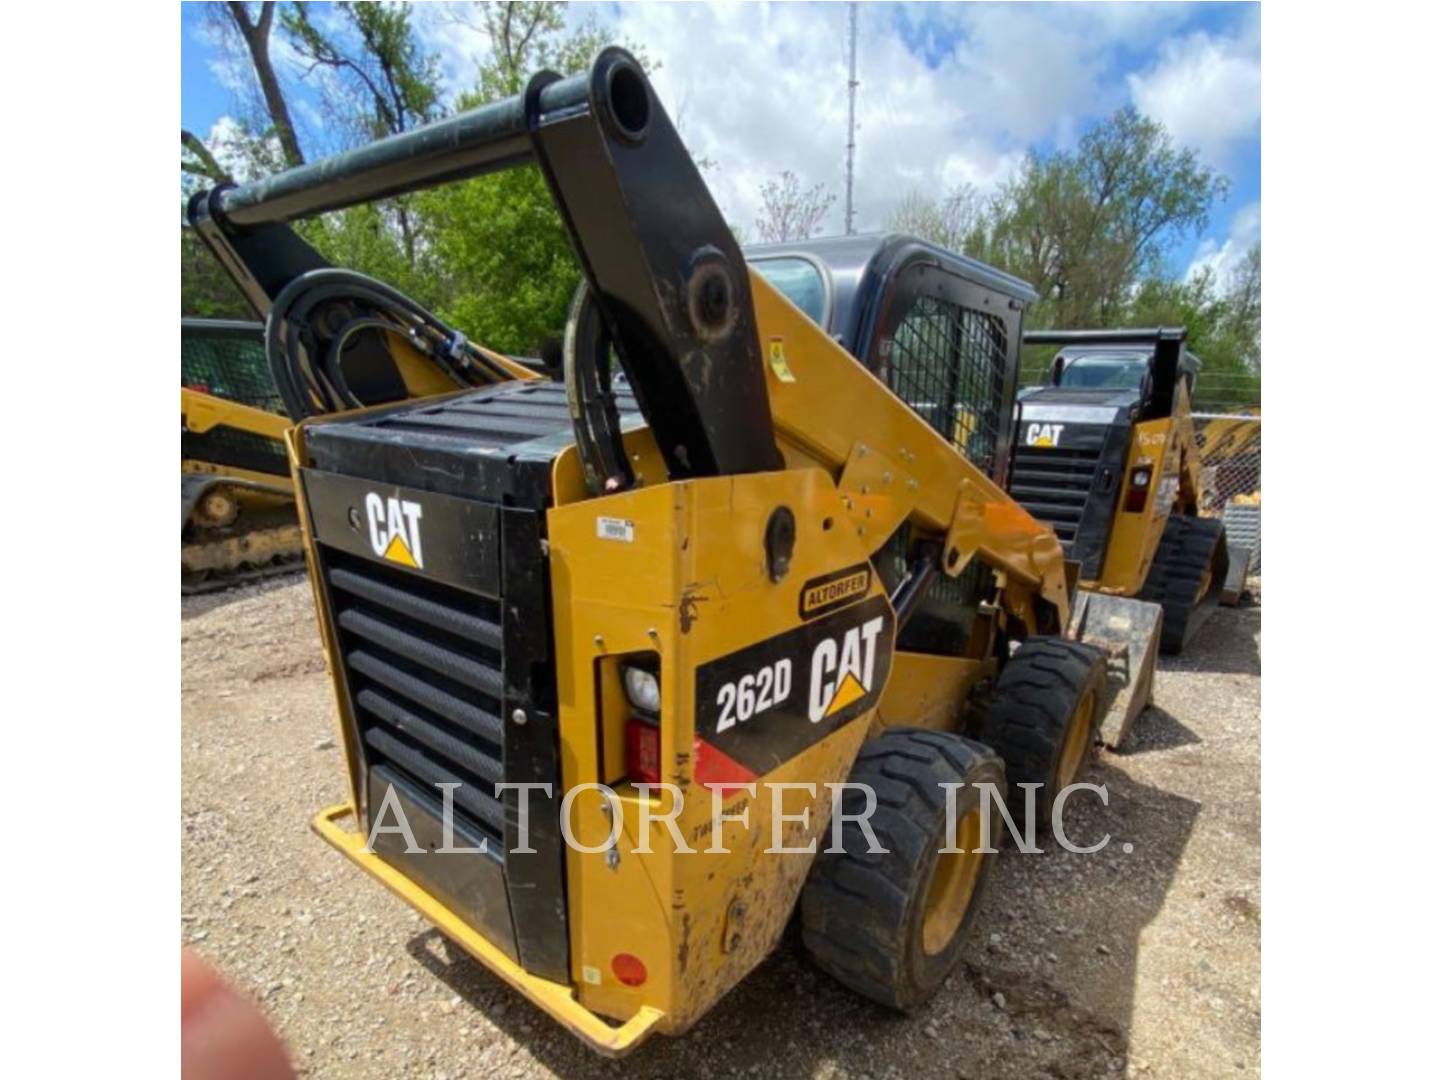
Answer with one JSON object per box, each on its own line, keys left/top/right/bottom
{"left": 180, "top": 318, "right": 304, "bottom": 593}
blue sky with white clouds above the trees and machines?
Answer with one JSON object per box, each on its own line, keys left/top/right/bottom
{"left": 180, "top": 3, "right": 1260, "bottom": 274}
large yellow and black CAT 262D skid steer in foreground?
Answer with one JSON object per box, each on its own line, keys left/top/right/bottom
{"left": 190, "top": 49, "right": 1146, "bottom": 1054}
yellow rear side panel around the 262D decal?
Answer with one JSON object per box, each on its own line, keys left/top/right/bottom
{"left": 550, "top": 469, "right": 894, "bottom": 1031}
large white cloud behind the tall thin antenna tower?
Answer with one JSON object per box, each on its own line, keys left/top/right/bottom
{"left": 575, "top": 4, "right": 1082, "bottom": 232}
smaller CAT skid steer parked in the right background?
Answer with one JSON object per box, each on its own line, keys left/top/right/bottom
{"left": 1009, "top": 328, "right": 1230, "bottom": 722}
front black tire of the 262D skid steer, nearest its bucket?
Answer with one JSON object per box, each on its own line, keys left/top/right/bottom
{"left": 982, "top": 638, "right": 1104, "bottom": 829}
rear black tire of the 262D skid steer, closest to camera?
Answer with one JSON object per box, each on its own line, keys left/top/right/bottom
{"left": 801, "top": 727, "right": 1005, "bottom": 1012}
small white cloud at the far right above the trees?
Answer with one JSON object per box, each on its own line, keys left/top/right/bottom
{"left": 1126, "top": 24, "right": 1260, "bottom": 167}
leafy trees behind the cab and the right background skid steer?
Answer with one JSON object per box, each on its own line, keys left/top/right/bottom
{"left": 886, "top": 108, "right": 1260, "bottom": 408}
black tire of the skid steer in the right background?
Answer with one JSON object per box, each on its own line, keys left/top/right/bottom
{"left": 1140, "top": 514, "right": 1230, "bottom": 655}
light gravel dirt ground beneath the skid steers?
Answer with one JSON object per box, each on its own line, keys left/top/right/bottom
{"left": 180, "top": 576, "right": 1260, "bottom": 1080}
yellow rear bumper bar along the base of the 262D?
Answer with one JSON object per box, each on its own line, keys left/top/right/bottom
{"left": 310, "top": 802, "right": 665, "bottom": 1057}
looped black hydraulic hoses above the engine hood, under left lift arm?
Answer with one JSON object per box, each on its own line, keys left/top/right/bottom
{"left": 265, "top": 268, "right": 513, "bottom": 420}
